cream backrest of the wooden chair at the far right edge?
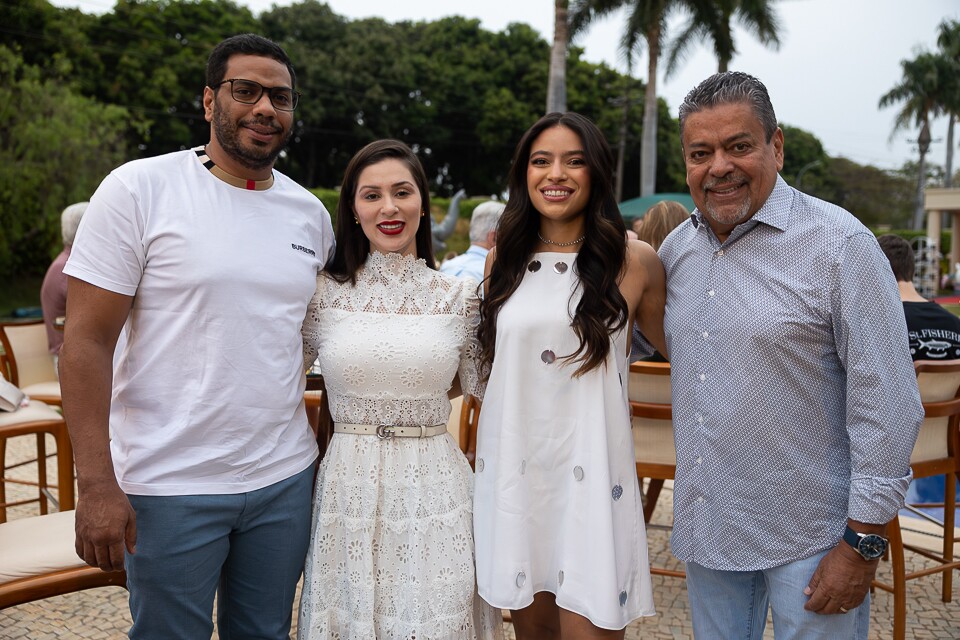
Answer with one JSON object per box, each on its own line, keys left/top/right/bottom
{"left": 910, "top": 360, "right": 960, "bottom": 475}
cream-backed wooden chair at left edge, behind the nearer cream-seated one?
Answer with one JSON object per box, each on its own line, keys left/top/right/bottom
{"left": 0, "top": 320, "right": 61, "bottom": 406}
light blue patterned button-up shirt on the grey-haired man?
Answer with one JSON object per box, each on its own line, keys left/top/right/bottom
{"left": 660, "top": 177, "right": 923, "bottom": 571}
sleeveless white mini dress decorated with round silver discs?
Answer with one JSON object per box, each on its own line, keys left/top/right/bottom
{"left": 474, "top": 252, "right": 654, "bottom": 629}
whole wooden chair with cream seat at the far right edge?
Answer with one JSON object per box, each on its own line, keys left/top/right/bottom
{"left": 873, "top": 360, "right": 960, "bottom": 640}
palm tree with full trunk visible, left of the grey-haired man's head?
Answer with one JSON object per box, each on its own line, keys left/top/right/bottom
{"left": 570, "top": 0, "right": 719, "bottom": 196}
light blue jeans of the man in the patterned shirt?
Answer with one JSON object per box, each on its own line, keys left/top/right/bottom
{"left": 686, "top": 551, "right": 870, "bottom": 640}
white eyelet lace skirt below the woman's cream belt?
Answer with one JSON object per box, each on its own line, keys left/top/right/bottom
{"left": 298, "top": 434, "right": 503, "bottom": 640}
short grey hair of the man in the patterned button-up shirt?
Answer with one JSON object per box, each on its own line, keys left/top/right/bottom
{"left": 680, "top": 71, "right": 777, "bottom": 142}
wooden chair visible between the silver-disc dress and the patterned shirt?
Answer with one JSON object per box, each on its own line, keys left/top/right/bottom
{"left": 627, "top": 362, "right": 686, "bottom": 578}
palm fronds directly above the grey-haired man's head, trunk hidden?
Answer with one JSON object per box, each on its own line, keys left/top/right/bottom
{"left": 666, "top": 0, "right": 780, "bottom": 77}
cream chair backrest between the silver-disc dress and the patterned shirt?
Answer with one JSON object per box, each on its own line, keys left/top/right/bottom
{"left": 627, "top": 361, "right": 677, "bottom": 468}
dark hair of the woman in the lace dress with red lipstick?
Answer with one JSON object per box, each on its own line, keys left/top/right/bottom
{"left": 327, "top": 140, "right": 437, "bottom": 284}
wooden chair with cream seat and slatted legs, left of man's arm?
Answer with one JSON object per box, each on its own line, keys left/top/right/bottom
{"left": 0, "top": 400, "right": 74, "bottom": 523}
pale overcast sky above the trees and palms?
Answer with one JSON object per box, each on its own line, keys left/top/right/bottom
{"left": 53, "top": 0, "right": 960, "bottom": 170}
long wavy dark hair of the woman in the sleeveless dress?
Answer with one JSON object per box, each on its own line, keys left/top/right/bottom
{"left": 477, "top": 112, "right": 628, "bottom": 376}
